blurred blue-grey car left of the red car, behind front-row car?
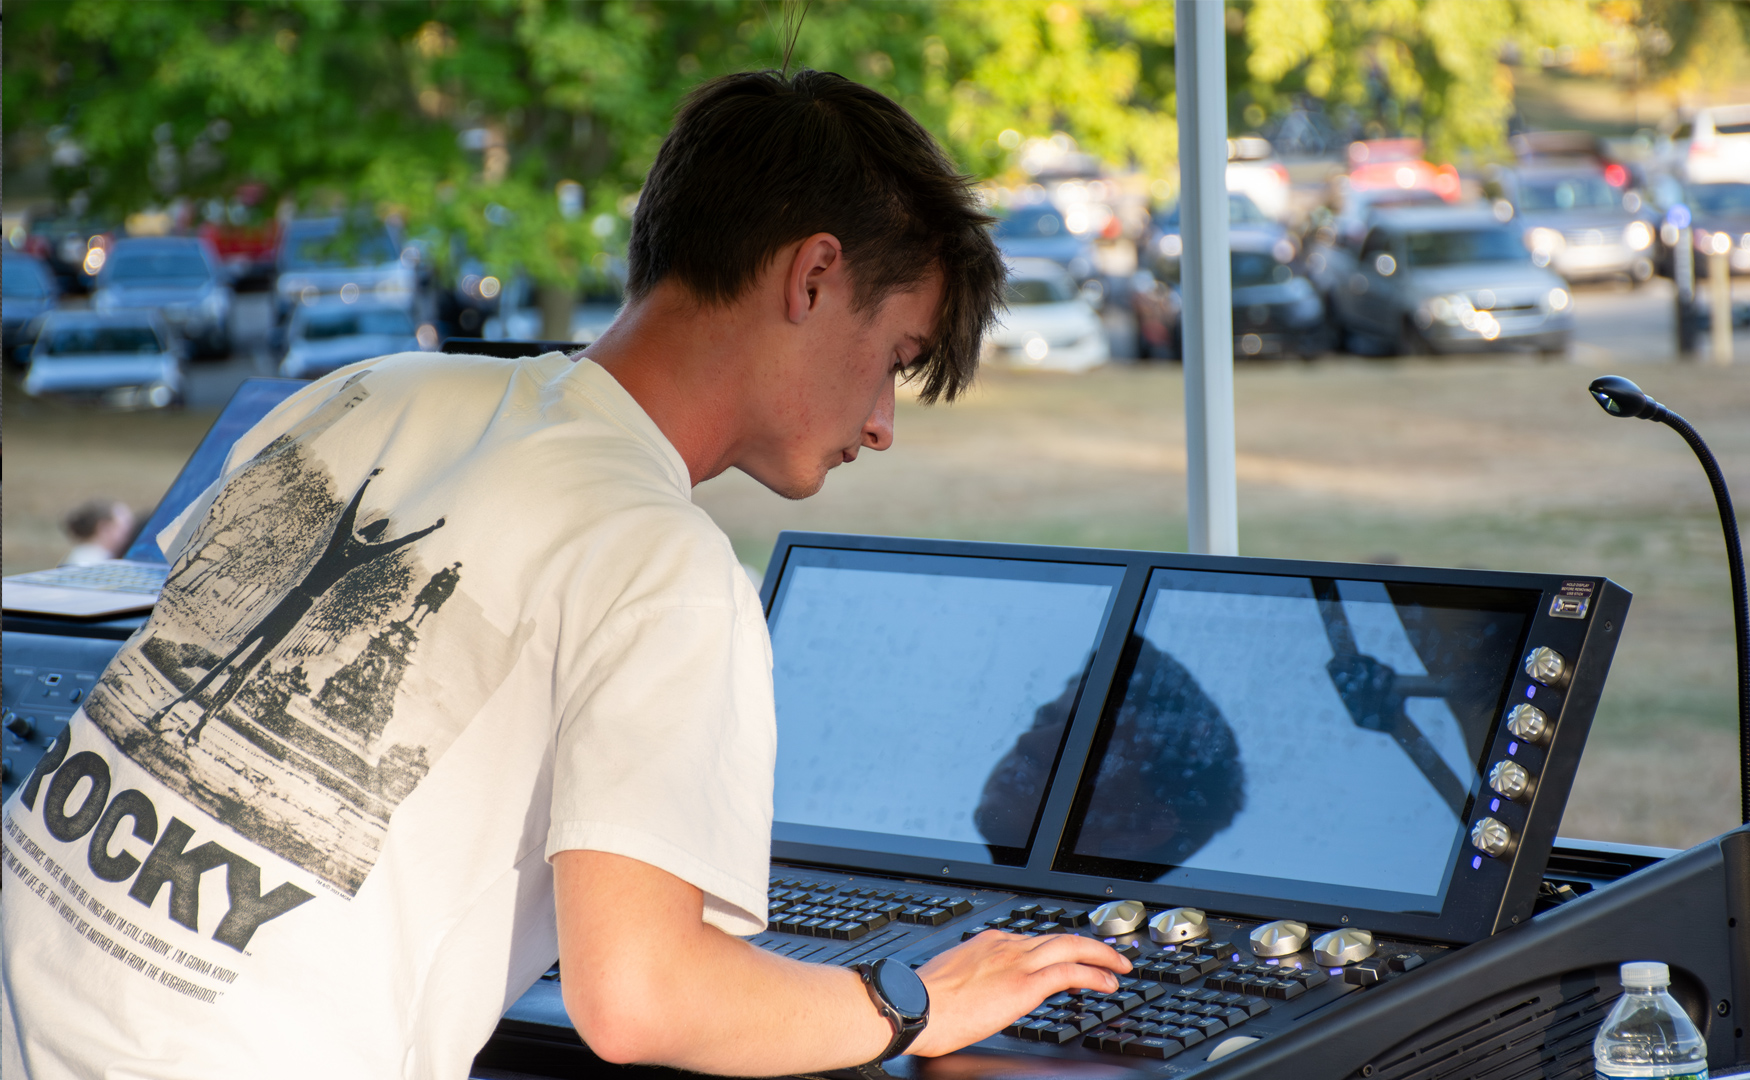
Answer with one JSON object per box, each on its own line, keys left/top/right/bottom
{"left": 91, "top": 236, "right": 231, "bottom": 357}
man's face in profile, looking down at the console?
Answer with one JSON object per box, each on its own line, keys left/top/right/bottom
{"left": 737, "top": 273, "right": 942, "bottom": 499}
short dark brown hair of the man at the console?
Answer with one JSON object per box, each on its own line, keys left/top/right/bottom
{"left": 627, "top": 70, "right": 1005, "bottom": 403}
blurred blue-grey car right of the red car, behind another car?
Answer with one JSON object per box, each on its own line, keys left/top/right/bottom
{"left": 273, "top": 217, "right": 418, "bottom": 326}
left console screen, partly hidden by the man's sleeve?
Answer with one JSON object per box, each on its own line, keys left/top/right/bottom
{"left": 768, "top": 546, "right": 1124, "bottom": 865}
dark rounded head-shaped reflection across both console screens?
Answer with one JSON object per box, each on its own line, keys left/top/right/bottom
{"left": 973, "top": 639, "right": 1246, "bottom": 865}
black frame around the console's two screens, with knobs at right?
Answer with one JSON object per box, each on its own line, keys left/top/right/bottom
{"left": 761, "top": 532, "right": 1629, "bottom": 943}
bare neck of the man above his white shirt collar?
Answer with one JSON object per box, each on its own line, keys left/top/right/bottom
{"left": 583, "top": 282, "right": 754, "bottom": 485}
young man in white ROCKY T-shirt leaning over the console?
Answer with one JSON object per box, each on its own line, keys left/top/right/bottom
{"left": 0, "top": 72, "right": 1129, "bottom": 1080}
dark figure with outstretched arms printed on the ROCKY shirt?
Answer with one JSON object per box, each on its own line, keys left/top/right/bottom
{"left": 147, "top": 469, "right": 444, "bottom": 744}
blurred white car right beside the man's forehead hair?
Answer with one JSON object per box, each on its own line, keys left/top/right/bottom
{"left": 985, "top": 259, "right": 1111, "bottom": 371}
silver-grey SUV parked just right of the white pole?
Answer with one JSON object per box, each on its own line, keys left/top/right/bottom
{"left": 1332, "top": 210, "right": 1573, "bottom": 355}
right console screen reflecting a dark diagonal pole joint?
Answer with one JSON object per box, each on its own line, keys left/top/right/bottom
{"left": 1057, "top": 569, "right": 1540, "bottom": 914}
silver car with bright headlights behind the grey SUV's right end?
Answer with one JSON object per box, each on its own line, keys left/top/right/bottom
{"left": 1498, "top": 165, "right": 1657, "bottom": 285}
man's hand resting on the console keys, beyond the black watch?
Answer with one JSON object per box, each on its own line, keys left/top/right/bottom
{"left": 908, "top": 929, "right": 1131, "bottom": 1057}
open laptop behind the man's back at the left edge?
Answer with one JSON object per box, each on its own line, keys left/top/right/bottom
{"left": 0, "top": 378, "right": 308, "bottom": 620}
